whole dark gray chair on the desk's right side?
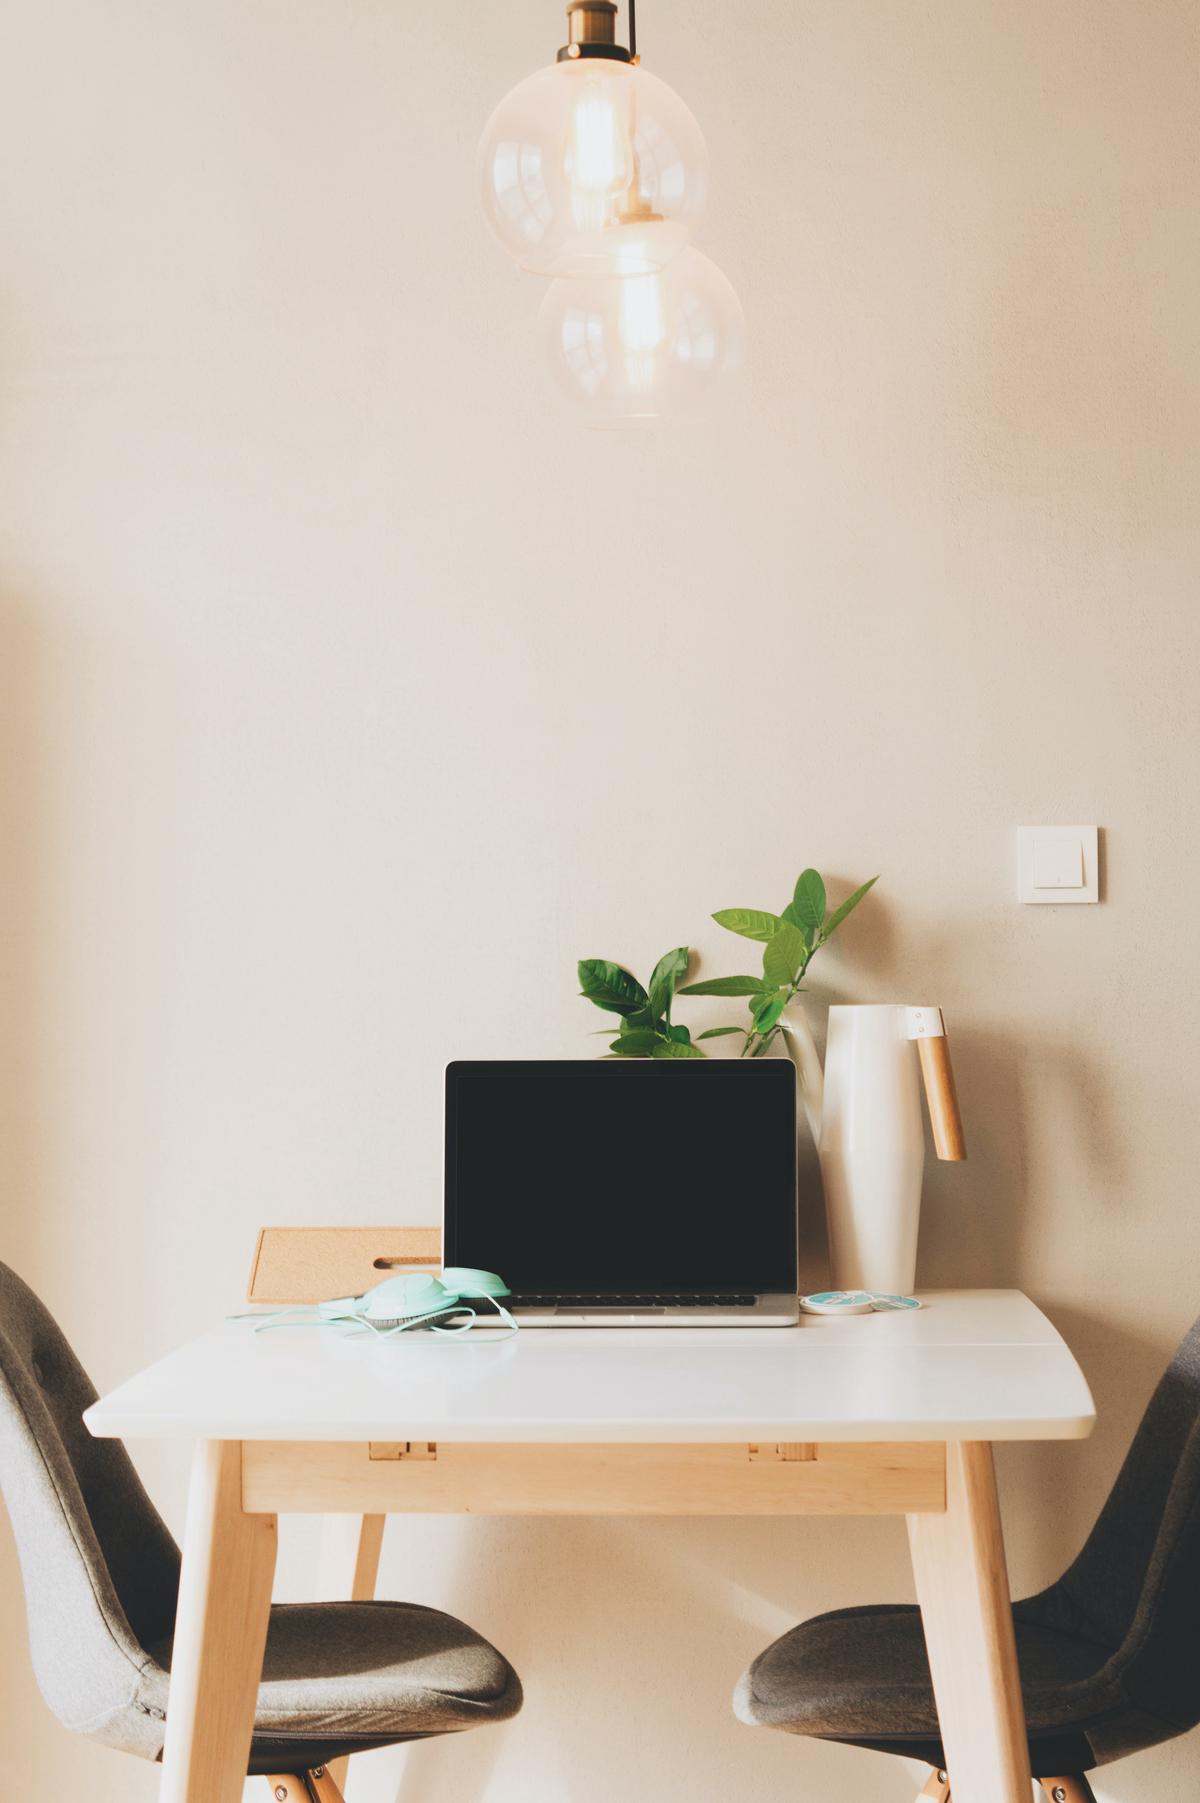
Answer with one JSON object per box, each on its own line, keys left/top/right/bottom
{"left": 733, "top": 1322, "right": 1200, "bottom": 1803}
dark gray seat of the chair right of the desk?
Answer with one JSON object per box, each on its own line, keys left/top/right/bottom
{"left": 733, "top": 1605, "right": 1119, "bottom": 1771}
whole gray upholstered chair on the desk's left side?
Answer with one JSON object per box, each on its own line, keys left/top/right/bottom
{"left": 0, "top": 1264, "right": 521, "bottom": 1803}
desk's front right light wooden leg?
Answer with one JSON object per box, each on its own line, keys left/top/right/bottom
{"left": 908, "top": 1441, "right": 1032, "bottom": 1803}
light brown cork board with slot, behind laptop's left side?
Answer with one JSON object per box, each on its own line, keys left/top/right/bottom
{"left": 247, "top": 1228, "right": 441, "bottom": 1302}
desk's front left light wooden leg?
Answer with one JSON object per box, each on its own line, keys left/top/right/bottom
{"left": 159, "top": 1441, "right": 276, "bottom": 1803}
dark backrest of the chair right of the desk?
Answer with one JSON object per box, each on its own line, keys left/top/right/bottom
{"left": 1018, "top": 1322, "right": 1200, "bottom": 1738}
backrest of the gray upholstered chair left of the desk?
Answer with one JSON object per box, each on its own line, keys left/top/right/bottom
{"left": 0, "top": 1264, "right": 178, "bottom": 1756}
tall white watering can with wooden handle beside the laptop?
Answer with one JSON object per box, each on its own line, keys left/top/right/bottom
{"left": 780, "top": 1002, "right": 966, "bottom": 1295}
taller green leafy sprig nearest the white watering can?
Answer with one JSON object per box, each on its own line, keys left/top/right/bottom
{"left": 679, "top": 871, "right": 879, "bottom": 1058}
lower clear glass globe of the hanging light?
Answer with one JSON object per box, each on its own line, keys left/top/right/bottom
{"left": 539, "top": 247, "right": 746, "bottom": 426}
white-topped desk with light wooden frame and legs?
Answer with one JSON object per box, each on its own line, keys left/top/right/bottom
{"left": 86, "top": 1291, "right": 1094, "bottom": 1803}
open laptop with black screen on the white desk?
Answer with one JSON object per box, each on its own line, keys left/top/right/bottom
{"left": 443, "top": 1058, "right": 798, "bottom": 1327}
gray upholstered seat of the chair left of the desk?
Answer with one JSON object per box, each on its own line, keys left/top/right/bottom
{"left": 140, "top": 1603, "right": 521, "bottom": 1772}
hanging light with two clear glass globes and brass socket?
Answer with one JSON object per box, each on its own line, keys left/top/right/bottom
{"left": 479, "top": 0, "right": 744, "bottom": 426}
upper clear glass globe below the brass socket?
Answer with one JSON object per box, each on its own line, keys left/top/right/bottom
{"left": 479, "top": 58, "right": 708, "bottom": 276}
